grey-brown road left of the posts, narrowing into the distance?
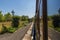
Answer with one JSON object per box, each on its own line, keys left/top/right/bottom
{"left": 0, "top": 23, "right": 31, "bottom": 40}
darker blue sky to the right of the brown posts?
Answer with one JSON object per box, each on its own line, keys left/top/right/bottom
{"left": 47, "top": 0, "right": 60, "bottom": 15}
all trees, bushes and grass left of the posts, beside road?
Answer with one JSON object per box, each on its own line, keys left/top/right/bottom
{"left": 0, "top": 10, "right": 32, "bottom": 34}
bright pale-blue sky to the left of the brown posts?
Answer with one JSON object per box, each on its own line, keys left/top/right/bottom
{"left": 0, "top": 0, "right": 35, "bottom": 17}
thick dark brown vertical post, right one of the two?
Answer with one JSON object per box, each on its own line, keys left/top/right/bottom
{"left": 42, "top": 0, "right": 48, "bottom": 40}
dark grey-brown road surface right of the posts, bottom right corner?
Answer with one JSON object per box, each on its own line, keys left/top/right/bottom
{"left": 48, "top": 27, "right": 60, "bottom": 40}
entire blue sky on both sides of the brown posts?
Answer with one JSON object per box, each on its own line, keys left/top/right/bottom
{"left": 0, "top": 0, "right": 60, "bottom": 17}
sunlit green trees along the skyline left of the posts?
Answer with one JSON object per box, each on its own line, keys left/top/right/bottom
{"left": 0, "top": 10, "right": 30, "bottom": 22}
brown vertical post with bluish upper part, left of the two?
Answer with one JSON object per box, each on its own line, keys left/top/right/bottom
{"left": 35, "top": 0, "right": 40, "bottom": 40}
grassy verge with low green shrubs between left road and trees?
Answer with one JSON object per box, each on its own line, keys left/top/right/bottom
{"left": 0, "top": 21, "right": 28, "bottom": 34}
